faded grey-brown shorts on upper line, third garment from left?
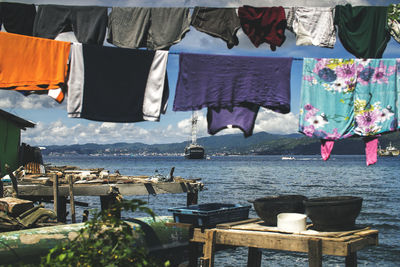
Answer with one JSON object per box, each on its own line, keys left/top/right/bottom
{"left": 107, "top": 7, "right": 190, "bottom": 50}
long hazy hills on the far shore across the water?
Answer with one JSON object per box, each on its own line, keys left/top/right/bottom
{"left": 42, "top": 132, "right": 400, "bottom": 155}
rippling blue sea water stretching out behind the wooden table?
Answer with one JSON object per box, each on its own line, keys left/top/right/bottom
{"left": 44, "top": 155, "right": 400, "bottom": 267}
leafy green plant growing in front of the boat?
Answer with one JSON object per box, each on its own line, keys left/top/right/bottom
{"left": 41, "top": 199, "right": 169, "bottom": 267}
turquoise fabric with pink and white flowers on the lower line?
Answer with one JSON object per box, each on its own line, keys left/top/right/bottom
{"left": 299, "top": 58, "right": 400, "bottom": 140}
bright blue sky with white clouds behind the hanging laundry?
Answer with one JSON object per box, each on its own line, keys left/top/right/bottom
{"left": 0, "top": 0, "right": 400, "bottom": 146}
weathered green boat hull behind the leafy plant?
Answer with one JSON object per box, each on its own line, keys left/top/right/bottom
{"left": 0, "top": 216, "right": 189, "bottom": 265}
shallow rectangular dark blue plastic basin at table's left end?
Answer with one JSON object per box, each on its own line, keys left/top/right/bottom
{"left": 168, "top": 203, "right": 251, "bottom": 228}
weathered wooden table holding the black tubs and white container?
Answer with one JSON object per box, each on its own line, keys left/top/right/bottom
{"left": 175, "top": 219, "right": 378, "bottom": 267}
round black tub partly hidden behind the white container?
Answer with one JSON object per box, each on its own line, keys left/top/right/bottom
{"left": 249, "top": 195, "right": 307, "bottom": 226}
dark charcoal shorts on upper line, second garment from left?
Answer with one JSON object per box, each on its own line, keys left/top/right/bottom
{"left": 33, "top": 5, "right": 108, "bottom": 45}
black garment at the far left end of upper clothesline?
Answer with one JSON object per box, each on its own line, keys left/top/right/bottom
{"left": 0, "top": 2, "right": 36, "bottom": 36}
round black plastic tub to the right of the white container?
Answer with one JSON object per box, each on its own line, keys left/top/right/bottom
{"left": 304, "top": 196, "right": 363, "bottom": 231}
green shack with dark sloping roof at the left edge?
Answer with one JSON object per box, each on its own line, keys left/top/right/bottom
{"left": 0, "top": 109, "right": 35, "bottom": 177}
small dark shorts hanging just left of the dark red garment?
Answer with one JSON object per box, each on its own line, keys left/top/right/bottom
{"left": 191, "top": 7, "right": 240, "bottom": 49}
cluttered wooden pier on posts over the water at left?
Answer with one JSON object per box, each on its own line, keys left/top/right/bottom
{"left": 4, "top": 167, "right": 204, "bottom": 222}
